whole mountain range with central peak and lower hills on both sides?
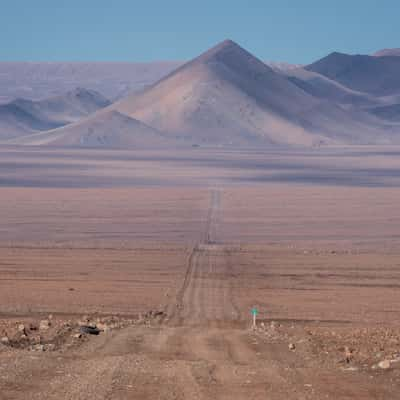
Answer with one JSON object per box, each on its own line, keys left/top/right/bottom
{"left": 0, "top": 40, "right": 400, "bottom": 147}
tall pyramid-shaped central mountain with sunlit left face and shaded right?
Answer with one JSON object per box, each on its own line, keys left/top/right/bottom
{"left": 114, "top": 40, "right": 396, "bottom": 145}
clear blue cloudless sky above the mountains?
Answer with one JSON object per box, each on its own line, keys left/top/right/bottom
{"left": 0, "top": 0, "right": 400, "bottom": 63}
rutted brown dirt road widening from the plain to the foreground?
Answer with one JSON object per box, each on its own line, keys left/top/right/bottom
{"left": 0, "top": 189, "right": 393, "bottom": 400}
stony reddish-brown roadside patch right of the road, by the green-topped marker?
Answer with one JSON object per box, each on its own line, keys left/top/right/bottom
{"left": 255, "top": 321, "right": 400, "bottom": 373}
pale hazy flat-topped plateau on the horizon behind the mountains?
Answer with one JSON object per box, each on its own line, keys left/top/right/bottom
{"left": 0, "top": 61, "right": 301, "bottom": 104}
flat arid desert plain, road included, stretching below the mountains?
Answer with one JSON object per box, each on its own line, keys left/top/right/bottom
{"left": 0, "top": 147, "right": 400, "bottom": 400}
